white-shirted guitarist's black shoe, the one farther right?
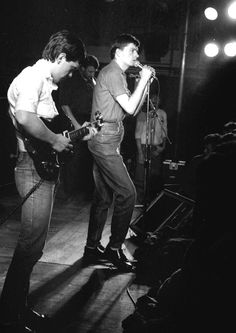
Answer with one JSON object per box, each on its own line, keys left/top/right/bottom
{"left": 21, "top": 308, "right": 50, "bottom": 328}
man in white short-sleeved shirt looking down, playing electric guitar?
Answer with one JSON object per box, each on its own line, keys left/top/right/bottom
{"left": 0, "top": 30, "right": 96, "bottom": 333}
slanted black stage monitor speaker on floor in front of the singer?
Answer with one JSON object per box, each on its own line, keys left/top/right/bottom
{"left": 130, "top": 189, "right": 194, "bottom": 236}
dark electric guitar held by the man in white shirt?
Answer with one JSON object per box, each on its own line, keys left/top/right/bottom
{"left": 20, "top": 111, "right": 103, "bottom": 181}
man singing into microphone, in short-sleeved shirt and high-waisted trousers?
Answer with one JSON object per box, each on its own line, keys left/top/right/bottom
{"left": 83, "top": 34, "right": 153, "bottom": 272}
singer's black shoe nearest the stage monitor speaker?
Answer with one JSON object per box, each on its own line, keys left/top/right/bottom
{"left": 103, "top": 247, "right": 135, "bottom": 272}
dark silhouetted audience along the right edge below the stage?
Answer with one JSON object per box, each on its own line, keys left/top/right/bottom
{"left": 123, "top": 126, "right": 236, "bottom": 333}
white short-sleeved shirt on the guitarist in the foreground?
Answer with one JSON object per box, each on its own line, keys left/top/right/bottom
{"left": 7, "top": 59, "right": 58, "bottom": 151}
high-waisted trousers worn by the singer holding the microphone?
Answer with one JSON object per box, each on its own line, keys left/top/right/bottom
{"left": 86, "top": 123, "right": 136, "bottom": 249}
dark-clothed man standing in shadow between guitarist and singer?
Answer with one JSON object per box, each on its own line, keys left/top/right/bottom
{"left": 58, "top": 54, "right": 99, "bottom": 200}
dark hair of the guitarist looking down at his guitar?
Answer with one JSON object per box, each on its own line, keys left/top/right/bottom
{"left": 42, "top": 30, "right": 86, "bottom": 63}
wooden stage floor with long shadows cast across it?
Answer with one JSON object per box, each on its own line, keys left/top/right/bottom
{"left": 0, "top": 186, "right": 150, "bottom": 333}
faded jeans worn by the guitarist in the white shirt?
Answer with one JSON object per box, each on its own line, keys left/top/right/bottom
{"left": 0, "top": 153, "right": 56, "bottom": 320}
